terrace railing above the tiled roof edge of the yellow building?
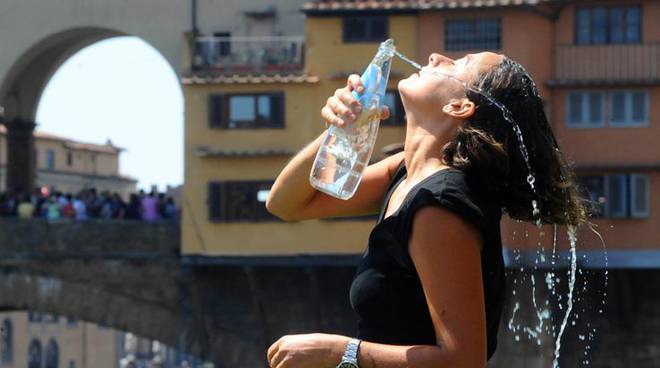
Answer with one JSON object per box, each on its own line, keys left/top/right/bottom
{"left": 193, "top": 36, "right": 304, "bottom": 74}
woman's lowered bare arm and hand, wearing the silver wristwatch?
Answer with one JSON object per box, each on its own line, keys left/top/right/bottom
{"left": 267, "top": 207, "right": 487, "bottom": 368}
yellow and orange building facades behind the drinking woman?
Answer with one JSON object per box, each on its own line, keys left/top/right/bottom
{"left": 182, "top": 0, "right": 660, "bottom": 262}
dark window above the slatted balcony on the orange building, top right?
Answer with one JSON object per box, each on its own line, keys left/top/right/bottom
{"left": 575, "top": 6, "right": 641, "bottom": 45}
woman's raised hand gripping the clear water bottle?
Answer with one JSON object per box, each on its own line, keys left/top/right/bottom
{"left": 321, "top": 74, "right": 390, "bottom": 128}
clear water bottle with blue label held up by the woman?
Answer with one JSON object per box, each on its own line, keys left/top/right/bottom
{"left": 309, "top": 39, "right": 396, "bottom": 200}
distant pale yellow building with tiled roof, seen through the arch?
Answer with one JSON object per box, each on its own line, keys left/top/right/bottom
{"left": 0, "top": 125, "right": 137, "bottom": 198}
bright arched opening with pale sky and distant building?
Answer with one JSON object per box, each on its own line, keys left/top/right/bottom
{"left": 35, "top": 36, "right": 183, "bottom": 193}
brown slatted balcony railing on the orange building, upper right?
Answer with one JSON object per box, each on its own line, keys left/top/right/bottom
{"left": 553, "top": 44, "right": 660, "bottom": 84}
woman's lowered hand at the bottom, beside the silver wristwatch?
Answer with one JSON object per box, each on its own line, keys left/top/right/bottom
{"left": 268, "top": 333, "right": 349, "bottom": 368}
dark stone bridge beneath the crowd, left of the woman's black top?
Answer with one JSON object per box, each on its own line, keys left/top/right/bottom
{"left": 0, "top": 219, "right": 355, "bottom": 367}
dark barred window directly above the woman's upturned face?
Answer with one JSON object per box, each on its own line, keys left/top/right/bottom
{"left": 445, "top": 18, "right": 502, "bottom": 51}
